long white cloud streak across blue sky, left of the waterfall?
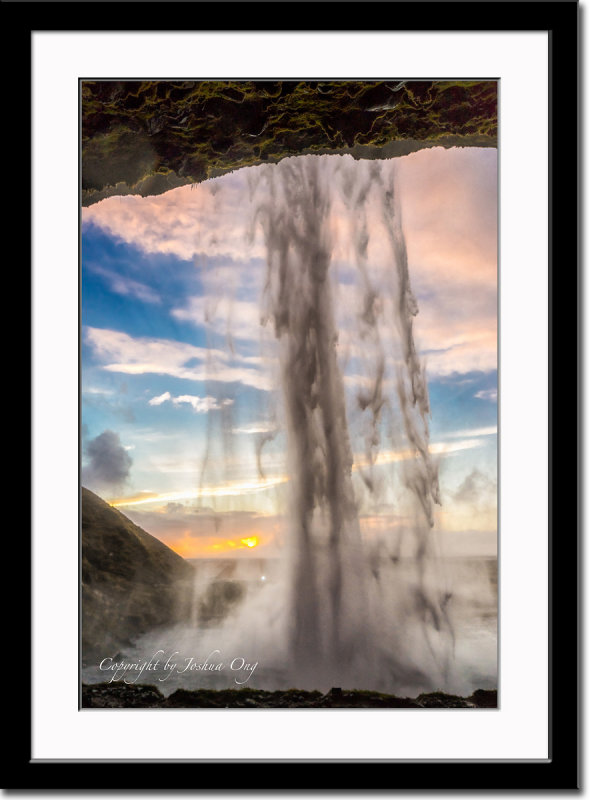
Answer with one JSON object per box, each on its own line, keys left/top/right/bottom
{"left": 85, "top": 327, "right": 273, "bottom": 392}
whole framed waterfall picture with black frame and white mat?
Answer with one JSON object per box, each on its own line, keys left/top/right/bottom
{"left": 19, "top": 2, "right": 578, "bottom": 790}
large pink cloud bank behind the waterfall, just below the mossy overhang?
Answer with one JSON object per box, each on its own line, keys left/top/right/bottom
{"left": 83, "top": 153, "right": 497, "bottom": 380}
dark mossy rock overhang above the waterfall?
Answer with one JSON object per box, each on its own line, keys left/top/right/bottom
{"left": 81, "top": 80, "right": 497, "bottom": 205}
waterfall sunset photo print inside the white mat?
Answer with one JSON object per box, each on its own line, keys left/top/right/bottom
{"left": 79, "top": 76, "right": 499, "bottom": 713}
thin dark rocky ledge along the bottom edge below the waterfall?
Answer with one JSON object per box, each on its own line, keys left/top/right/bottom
{"left": 82, "top": 683, "right": 498, "bottom": 709}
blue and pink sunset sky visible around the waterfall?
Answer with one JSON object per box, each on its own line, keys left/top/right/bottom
{"left": 81, "top": 148, "right": 498, "bottom": 558}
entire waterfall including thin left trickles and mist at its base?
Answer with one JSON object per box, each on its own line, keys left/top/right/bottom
{"left": 120, "top": 155, "right": 464, "bottom": 696}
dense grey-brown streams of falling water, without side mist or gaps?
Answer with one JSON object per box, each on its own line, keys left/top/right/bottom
{"left": 245, "top": 156, "right": 453, "bottom": 684}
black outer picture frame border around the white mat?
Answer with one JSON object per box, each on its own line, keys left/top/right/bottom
{"left": 15, "top": 0, "right": 581, "bottom": 791}
